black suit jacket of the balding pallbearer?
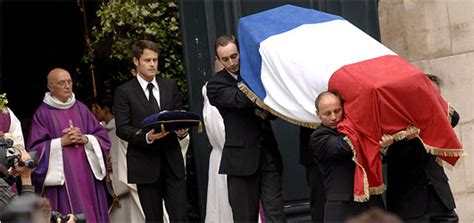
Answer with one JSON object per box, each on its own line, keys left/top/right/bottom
{"left": 309, "top": 125, "right": 355, "bottom": 201}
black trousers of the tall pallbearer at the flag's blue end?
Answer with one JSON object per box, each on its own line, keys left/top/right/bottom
{"left": 227, "top": 148, "right": 286, "bottom": 222}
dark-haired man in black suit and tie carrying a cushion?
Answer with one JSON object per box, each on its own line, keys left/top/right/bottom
{"left": 114, "top": 40, "right": 188, "bottom": 222}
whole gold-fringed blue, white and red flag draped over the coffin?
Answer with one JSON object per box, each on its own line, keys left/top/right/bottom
{"left": 238, "top": 5, "right": 462, "bottom": 201}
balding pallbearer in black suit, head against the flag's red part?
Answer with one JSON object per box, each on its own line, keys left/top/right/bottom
{"left": 309, "top": 91, "right": 384, "bottom": 222}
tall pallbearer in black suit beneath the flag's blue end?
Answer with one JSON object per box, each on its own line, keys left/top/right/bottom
{"left": 207, "top": 35, "right": 286, "bottom": 222}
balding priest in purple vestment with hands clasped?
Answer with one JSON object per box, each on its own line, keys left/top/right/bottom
{"left": 28, "top": 68, "right": 110, "bottom": 222}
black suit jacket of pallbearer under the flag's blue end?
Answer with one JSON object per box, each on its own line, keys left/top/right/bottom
{"left": 207, "top": 69, "right": 282, "bottom": 176}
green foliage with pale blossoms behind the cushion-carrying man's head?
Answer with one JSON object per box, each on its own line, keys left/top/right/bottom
{"left": 83, "top": 0, "right": 186, "bottom": 104}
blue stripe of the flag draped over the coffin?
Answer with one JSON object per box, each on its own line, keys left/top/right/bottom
{"left": 238, "top": 5, "right": 343, "bottom": 100}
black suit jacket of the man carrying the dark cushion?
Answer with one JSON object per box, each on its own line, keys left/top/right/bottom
{"left": 113, "top": 76, "right": 184, "bottom": 184}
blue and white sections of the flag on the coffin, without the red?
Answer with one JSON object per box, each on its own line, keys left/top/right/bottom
{"left": 238, "top": 5, "right": 396, "bottom": 126}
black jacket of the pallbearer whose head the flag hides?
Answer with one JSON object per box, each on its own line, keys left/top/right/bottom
{"left": 384, "top": 112, "right": 459, "bottom": 218}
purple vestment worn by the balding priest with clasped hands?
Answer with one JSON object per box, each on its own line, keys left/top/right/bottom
{"left": 28, "top": 101, "right": 110, "bottom": 223}
